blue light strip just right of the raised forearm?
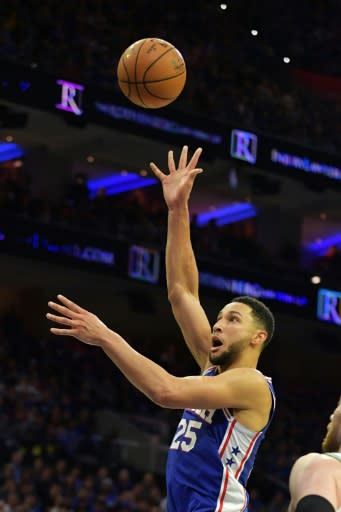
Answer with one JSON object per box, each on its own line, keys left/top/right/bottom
{"left": 197, "top": 203, "right": 257, "bottom": 227}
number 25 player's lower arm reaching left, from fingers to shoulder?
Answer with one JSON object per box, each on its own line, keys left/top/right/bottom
{"left": 47, "top": 295, "right": 269, "bottom": 411}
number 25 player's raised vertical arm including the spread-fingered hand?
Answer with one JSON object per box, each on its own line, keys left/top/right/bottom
{"left": 150, "top": 146, "right": 211, "bottom": 370}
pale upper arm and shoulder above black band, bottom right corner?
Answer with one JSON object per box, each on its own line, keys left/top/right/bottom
{"left": 288, "top": 453, "right": 337, "bottom": 512}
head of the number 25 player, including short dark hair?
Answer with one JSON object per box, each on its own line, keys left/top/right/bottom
{"left": 209, "top": 296, "right": 275, "bottom": 366}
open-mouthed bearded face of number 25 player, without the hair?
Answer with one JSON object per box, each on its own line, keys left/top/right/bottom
{"left": 209, "top": 302, "right": 257, "bottom": 366}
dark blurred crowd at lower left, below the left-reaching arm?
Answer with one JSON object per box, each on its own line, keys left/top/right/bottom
{"left": 0, "top": 312, "right": 170, "bottom": 512}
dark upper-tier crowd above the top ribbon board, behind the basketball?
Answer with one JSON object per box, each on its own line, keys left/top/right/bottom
{"left": 0, "top": 0, "right": 341, "bottom": 152}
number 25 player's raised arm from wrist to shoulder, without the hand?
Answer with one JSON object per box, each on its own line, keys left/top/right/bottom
{"left": 166, "top": 204, "right": 211, "bottom": 370}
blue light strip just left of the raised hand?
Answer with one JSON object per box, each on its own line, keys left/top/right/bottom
{"left": 88, "top": 172, "right": 157, "bottom": 199}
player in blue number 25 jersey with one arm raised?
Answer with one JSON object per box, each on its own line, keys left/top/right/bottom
{"left": 47, "top": 147, "right": 275, "bottom": 512}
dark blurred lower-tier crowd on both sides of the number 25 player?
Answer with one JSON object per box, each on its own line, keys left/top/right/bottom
{"left": 0, "top": 310, "right": 335, "bottom": 512}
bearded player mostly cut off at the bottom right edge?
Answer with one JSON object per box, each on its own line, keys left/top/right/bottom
{"left": 289, "top": 398, "right": 341, "bottom": 512}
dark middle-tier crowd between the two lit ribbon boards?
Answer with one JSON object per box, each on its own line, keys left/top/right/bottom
{"left": 0, "top": 167, "right": 341, "bottom": 278}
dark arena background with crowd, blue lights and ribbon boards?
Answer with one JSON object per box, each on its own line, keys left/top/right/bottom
{"left": 0, "top": 0, "right": 341, "bottom": 512}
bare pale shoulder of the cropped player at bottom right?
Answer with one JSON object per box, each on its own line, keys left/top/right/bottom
{"left": 289, "top": 453, "right": 337, "bottom": 512}
